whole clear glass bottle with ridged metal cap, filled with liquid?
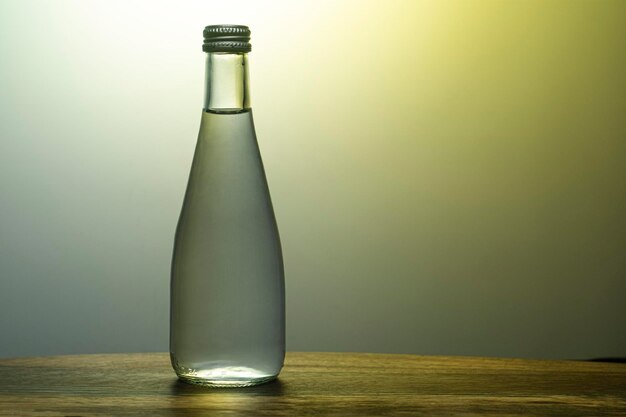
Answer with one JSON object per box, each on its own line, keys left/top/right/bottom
{"left": 170, "top": 25, "right": 285, "bottom": 386}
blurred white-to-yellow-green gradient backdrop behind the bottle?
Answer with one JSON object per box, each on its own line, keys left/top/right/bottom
{"left": 0, "top": 0, "right": 626, "bottom": 358}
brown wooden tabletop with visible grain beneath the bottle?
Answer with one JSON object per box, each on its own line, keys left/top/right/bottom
{"left": 0, "top": 353, "right": 626, "bottom": 417}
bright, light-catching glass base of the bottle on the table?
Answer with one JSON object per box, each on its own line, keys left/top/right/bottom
{"left": 177, "top": 366, "right": 278, "bottom": 388}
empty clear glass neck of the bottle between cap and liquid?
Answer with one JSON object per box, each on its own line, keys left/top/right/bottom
{"left": 204, "top": 52, "right": 250, "bottom": 113}
